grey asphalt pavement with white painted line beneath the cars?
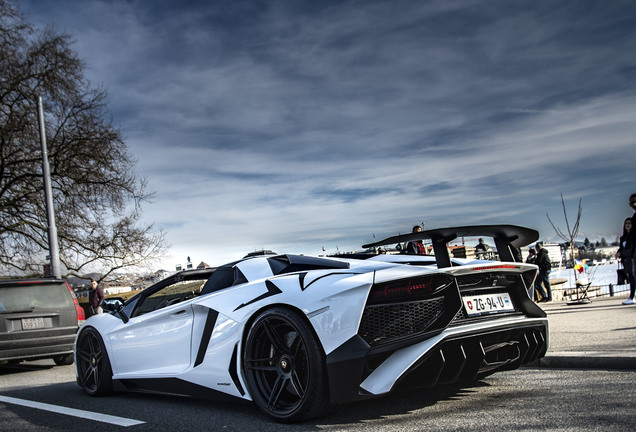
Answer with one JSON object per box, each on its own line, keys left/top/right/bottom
{"left": 0, "top": 361, "right": 636, "bottom": 432}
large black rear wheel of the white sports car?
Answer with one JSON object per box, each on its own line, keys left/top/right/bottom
{"left": 243, "top": 308, "right": 330, "bottom": 423}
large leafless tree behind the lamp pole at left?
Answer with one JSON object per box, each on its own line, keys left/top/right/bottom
{"left": 0, "top": 0, "right": 166, "bottom": 277}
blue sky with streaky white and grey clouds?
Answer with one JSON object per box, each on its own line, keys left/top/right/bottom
{"left": 19, "top": 0, "right": 636, "bottom": 268}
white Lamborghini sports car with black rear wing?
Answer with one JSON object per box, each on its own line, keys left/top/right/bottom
{"left": 75, "top": 225, "right": 548, "bottom": 422}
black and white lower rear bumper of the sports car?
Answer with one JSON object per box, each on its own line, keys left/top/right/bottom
{"left": 327, "top": 316, "right": 549, "bottom": 403}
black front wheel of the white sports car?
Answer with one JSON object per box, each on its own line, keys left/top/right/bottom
{"left": 75, "top": 327, "right": 113, "bottom": 396}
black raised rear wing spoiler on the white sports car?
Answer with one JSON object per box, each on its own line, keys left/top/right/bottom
{"left": 362, "top": 225, "right": 539, "bottom": 268}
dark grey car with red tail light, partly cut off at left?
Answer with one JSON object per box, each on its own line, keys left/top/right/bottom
{"left": 0, "top": 279, "right": 85, "bottom": 365}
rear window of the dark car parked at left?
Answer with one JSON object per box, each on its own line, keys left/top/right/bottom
{"left": 0, "top": 283, "right": 73, "bottom": 313}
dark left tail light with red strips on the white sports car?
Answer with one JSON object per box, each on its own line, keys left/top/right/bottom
{"left": 367, "top": 274, "right": 453, "bottom": 305}
